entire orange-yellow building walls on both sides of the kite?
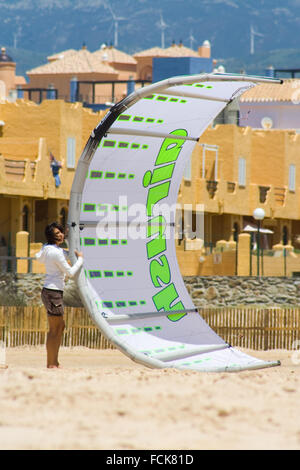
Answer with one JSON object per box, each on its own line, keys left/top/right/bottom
{"left": 0, "top": 100, "right": 300, "bottom": 275}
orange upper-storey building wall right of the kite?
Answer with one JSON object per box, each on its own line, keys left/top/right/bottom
{"left": 180, "top": 124, "right": 300, "bottom": 220}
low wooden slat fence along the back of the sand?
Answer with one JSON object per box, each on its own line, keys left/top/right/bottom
{"left": 0, "top": 306, "right": 300, "bottom": 350}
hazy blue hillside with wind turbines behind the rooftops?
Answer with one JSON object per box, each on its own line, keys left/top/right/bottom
{"left": 0, "top": 0, "right": 300, "bottom": 78}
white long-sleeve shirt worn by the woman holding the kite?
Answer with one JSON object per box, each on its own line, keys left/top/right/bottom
{"left": 35, "top": 245, "right": 83, "bottom": 291}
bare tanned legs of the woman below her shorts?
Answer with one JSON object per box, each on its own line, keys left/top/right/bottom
{"left": 46, "top": 315, "right": 65, "bottom": 369}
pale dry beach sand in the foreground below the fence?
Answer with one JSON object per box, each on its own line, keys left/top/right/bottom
{"left": 0, "top": 347, "right": 300, "bottom": 450}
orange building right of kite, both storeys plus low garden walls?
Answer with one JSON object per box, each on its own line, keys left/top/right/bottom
{"left": 178, "top": 125, "right": 300, "bottom": 274}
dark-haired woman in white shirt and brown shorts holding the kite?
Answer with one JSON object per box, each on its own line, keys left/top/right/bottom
{"left": 35, "top": 222, "right": 83, "bottom": 369}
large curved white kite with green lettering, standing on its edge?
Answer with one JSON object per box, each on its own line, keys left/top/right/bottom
{"left": 69, "top": 74, "right": 279, "bottom": 371}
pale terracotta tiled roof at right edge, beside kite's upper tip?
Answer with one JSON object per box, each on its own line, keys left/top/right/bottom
{"left": 240, "top": 79, "right": 300, "bottom": 103}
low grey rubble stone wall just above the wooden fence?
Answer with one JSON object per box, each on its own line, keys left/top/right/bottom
{"left": 0, "top": 273, "right": 300, "bottom": 307}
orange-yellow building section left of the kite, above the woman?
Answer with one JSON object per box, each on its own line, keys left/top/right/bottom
{"left": 0, "top": 100, "right": 104, "bottom": 248}
